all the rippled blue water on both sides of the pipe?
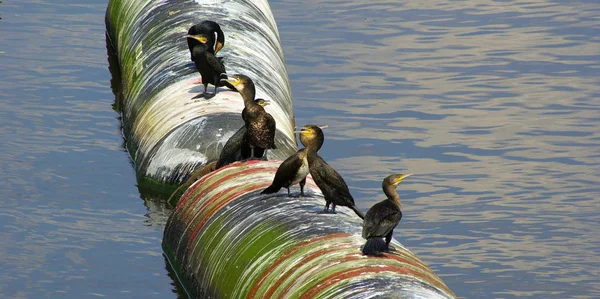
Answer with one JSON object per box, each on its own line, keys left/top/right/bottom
{"left": 0, "top": 0, "right": 600, "bottom": 298}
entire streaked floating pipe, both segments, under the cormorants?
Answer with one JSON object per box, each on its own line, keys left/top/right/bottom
{"left": 106, "top": 0, "right": 455, "bottom": 298}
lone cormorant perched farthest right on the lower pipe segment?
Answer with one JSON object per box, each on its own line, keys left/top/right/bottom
{"left": 362, "top": 173, "right": 412, "bottom": 255}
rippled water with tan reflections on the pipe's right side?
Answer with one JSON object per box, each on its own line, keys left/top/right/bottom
{"left": 274, "top": 0, "right": 600, "bottom": 298}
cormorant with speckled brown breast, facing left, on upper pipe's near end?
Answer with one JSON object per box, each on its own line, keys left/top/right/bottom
{"left": 222, "top": 74, "right": 277, "bottom": 159}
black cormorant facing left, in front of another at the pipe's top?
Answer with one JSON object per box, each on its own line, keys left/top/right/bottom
{"left": 187, "top": 34, "right": 225, "bottom": 99}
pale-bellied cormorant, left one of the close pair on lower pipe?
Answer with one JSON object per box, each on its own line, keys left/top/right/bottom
{"left": 260, "top": 125, "right": 324, "bottom": 196}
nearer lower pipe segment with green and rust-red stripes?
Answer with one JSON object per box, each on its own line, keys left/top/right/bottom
{"left": 163, "top": 161, "right": 455, "bottom": 298}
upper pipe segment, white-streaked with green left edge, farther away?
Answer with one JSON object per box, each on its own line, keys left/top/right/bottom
{"left": 106, "top": 0, "right": 296, "bottom": 183}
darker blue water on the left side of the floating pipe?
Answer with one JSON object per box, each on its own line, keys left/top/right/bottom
{"left": 0, "top": 0, "right": 178, "bottom": 298}
